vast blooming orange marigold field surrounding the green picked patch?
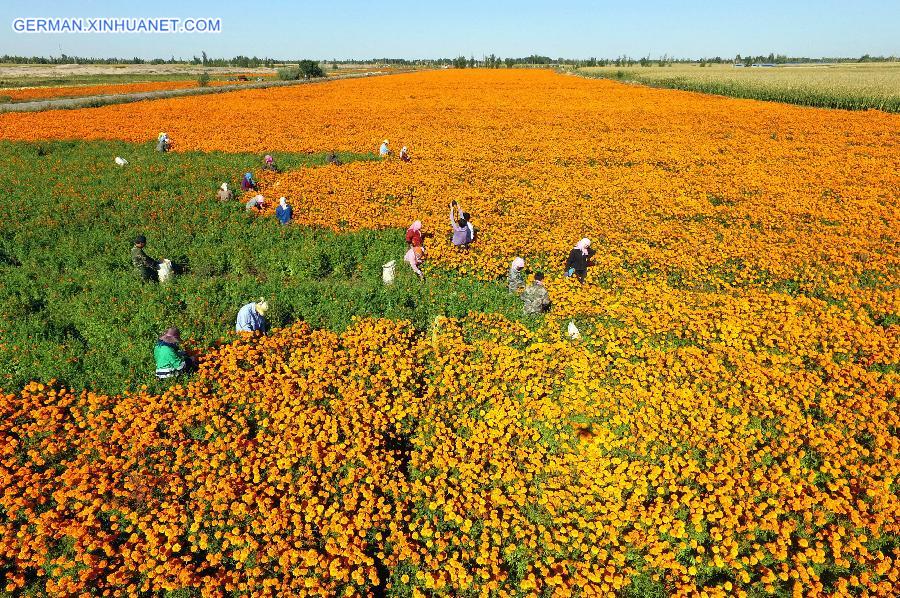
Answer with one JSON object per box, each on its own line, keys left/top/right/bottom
{"left": 0, "top": 70, "right": 900, "bottom": 597}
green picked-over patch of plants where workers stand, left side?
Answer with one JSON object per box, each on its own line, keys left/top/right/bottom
{"left": 0, "top": 141, "right": 521, "bottom": 392}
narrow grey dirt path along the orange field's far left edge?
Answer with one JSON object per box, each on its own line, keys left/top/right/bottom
{"left": 0, "top": 72, "right": 388, "bottom": 113}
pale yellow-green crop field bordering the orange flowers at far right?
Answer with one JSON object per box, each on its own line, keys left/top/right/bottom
{"left": 578, "top": 62, "right": 900, "bottom": 112}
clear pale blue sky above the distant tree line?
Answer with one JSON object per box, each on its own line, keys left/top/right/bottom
{"left": 0, "top": 0, "right": 900, "bottom": 59}
